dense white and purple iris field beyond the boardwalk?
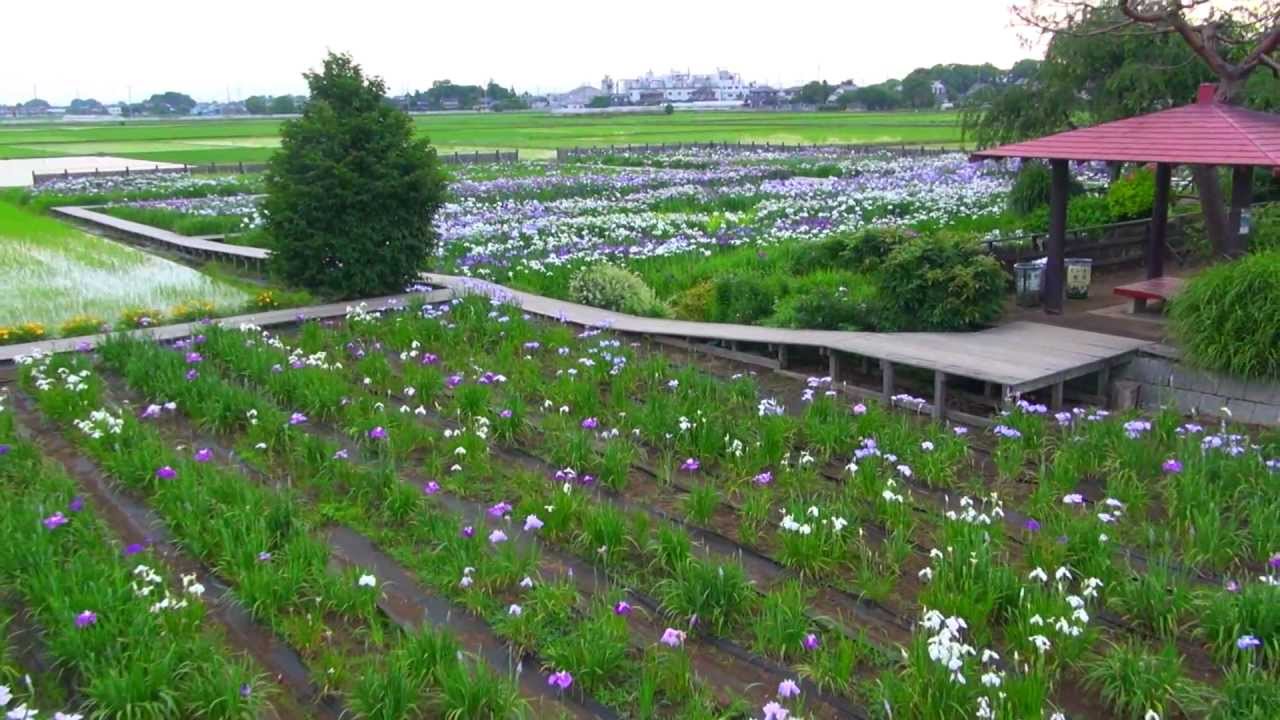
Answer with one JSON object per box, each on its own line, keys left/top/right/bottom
{"left": 92, "top": 150, "right": 1121, "bottom": 325}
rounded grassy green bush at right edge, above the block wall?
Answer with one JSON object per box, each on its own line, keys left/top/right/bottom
{"left": 1170, "top": 250, "right": 1280, "bottom": 379}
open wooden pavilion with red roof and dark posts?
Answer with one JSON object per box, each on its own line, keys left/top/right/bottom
{"left": 972, "top": 85, "right": 1280, "bottom": 314}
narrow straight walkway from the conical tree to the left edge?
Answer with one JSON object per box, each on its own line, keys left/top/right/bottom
{"left": 0, "top": 290, "right": 453, "bottom": 365}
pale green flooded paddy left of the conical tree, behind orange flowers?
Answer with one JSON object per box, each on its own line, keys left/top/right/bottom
{"left": 0, "top": 201, "right": 250, "bottom": 331}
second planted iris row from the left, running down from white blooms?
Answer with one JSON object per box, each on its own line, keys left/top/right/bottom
{"left": 8, "top": 357, "right": 555, "bottom": 717}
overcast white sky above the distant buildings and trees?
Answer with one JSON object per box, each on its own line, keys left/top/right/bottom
{"left": 0, "top": 0, "right": 1036, "bottom": 104}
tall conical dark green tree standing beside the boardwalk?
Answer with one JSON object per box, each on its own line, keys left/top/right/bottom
{"left": 262, "top": 54, "right": 445, "bottom": 299}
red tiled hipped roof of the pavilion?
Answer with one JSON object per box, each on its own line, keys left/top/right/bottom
{"left": 970, "top": 85, "right": 1280, "bottom": 167}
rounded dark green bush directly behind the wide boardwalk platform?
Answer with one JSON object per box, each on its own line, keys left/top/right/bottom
{"left": 879, "top": 234, "right": 1009, "bottom": 331}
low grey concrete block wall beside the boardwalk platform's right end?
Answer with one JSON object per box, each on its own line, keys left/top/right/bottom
{"left": 1112, "top": 346, "right": 1280, "bottom": 427}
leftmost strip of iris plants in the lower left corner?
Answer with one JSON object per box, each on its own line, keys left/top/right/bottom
{"left": 0, "top": 392, "right": 266, "bottom": 717}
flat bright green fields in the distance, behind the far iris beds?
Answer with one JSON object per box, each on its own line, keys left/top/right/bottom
{"left": 0, "top": 111, "right": 960, "bottom": 163}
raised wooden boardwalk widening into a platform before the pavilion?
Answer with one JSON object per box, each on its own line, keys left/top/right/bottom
{"left": 424, "top": 273, "right": 1149, "bottom": 414}
